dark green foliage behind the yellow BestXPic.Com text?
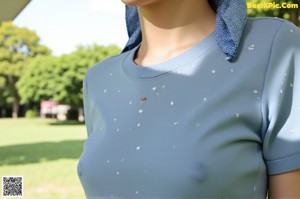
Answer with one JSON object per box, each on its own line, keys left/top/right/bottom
{"left": 247, "top": 0, "right": 300, "bottom": 26}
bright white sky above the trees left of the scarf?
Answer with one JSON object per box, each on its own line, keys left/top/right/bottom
{"left": 13, "top": 0, "right": 127, "bottom": 56}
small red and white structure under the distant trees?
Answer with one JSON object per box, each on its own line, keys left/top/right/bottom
{"left": 40, "top": 100, "right": 71, "bottom": 121}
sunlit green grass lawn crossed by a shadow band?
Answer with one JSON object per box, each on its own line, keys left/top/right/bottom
{"left": 0, "top": 119, "right": 86, "bottom": 199}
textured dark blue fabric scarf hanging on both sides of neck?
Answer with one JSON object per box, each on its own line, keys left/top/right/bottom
{"left": 122, "top": 0, "right": 247, "bottom": 61}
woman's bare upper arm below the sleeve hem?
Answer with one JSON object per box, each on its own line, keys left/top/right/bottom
{"left": 268, "top": 169, "right": 300, "bottom": 199}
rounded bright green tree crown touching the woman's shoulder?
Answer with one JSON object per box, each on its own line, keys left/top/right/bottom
{"left": 17, "top": 45, "right": 120, "bottom": 108}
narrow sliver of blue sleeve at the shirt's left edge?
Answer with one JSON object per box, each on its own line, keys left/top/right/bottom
{"left": 83, "top": 75, "right": 92, "bottom": 135}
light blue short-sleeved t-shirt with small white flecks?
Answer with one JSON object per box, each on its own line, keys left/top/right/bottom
{"left": 78, "top": 18, "right": 300, "bottom": 199}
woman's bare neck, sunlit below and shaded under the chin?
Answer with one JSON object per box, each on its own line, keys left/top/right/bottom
{"left": 135, "top": 0, "right": 215, "bottom": 66}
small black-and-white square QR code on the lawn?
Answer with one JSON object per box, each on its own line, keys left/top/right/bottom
{"left": 2, "top": 176, "right": 23, "bottom": 197}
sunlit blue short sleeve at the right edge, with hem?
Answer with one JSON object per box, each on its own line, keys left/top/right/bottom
{"left": 262, "top": 21, "right": 300, "bottom": 175}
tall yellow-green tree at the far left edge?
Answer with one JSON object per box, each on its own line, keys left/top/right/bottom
{"left": 0, "top": 22, "right": 50, "bottom": 118}
